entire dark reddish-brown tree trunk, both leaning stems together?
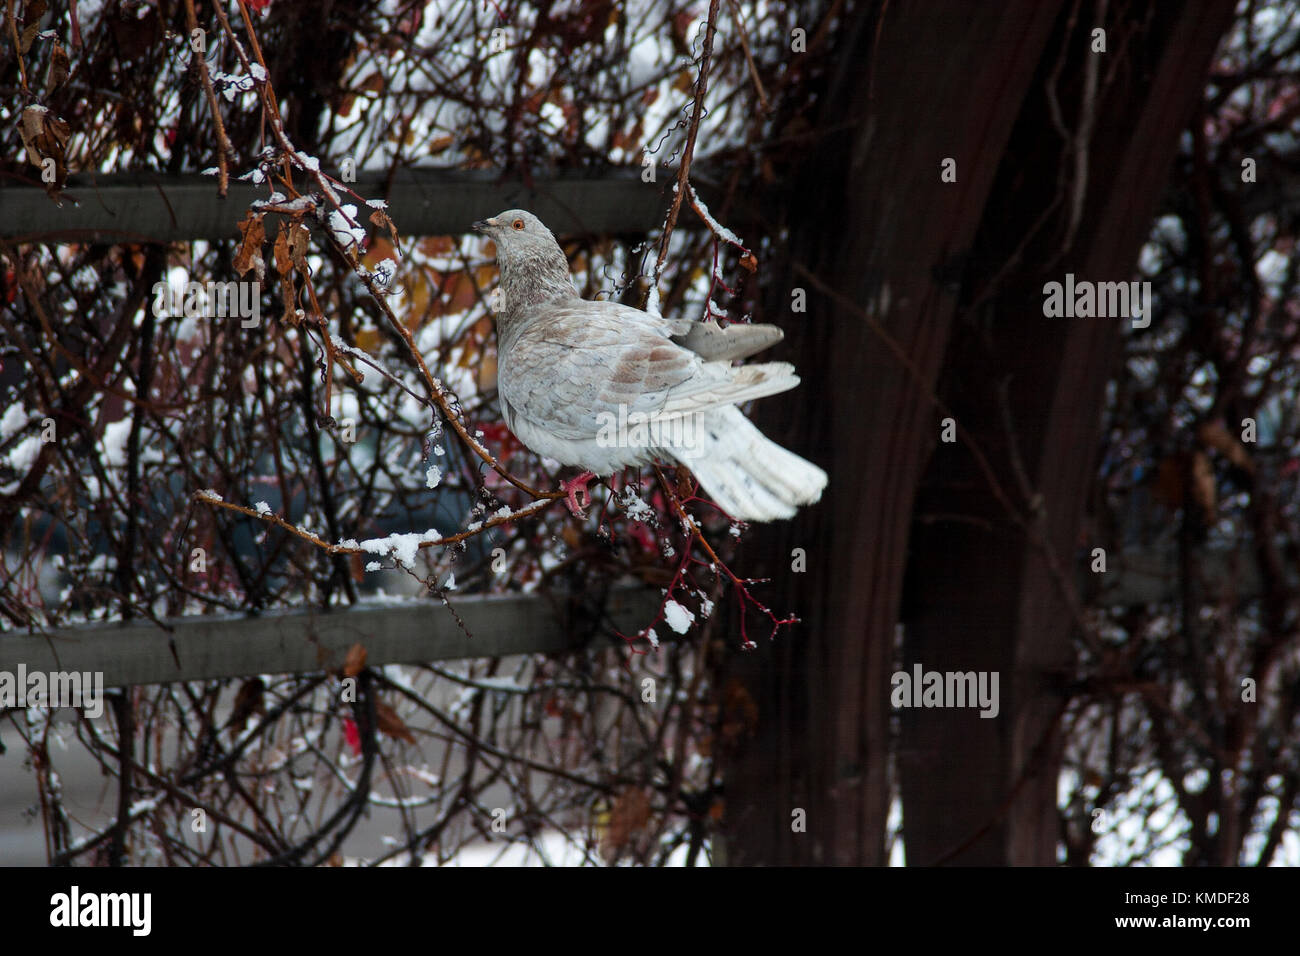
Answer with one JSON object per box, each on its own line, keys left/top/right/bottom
{"left": 724, "top": 0, "right": 1232, "bottom": 864}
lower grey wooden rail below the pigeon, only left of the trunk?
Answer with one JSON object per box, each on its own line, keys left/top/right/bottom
{"left": 0, "top": 588, "right": 662, "bottom": 687}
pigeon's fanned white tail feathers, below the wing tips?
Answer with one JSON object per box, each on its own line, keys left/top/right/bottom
{"left": 673, "top": 407, "right": 827, "bottom": 522}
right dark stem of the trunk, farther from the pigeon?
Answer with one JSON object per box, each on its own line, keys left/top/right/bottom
{"left": 900, "top": 0, "right": 1234, "bottom": 865}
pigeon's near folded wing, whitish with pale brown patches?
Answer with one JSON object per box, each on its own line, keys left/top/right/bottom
{"left": 498, "top": 300, "right": 798, "bottom": 440}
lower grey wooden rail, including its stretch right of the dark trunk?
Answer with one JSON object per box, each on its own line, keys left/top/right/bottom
{"left": 0, "top": 541, "right": 1279, "bottom": 687}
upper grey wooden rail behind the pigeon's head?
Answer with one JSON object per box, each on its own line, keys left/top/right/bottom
{"left": 0, "top": 164, "right": 735, "bottom": 243}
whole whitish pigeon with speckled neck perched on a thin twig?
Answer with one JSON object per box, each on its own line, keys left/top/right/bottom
{"left": 473, "top": 209, "right": 827, "bottom": 522}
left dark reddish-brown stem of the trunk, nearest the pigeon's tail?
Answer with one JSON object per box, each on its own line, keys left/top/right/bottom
{"left": 724, "top": 0, "right": 1057, "bottom": 864}
